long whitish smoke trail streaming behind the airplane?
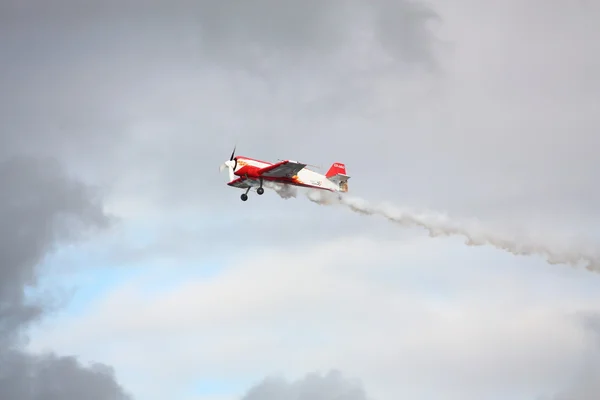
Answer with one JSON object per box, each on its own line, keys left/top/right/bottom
{"left": 307, "top": 191, "right": 600, "bottom": 272}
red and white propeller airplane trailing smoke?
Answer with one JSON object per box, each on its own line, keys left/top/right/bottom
{"left": 219, "top": 147, "right": 350, "bottom": 201}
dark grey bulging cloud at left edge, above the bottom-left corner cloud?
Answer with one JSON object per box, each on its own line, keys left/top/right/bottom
{"left": 0, "top": 157, "right": 108, "bottom": 336}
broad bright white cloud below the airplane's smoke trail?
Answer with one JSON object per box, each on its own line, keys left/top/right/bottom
{"left": 31, "top": 234, "right": 600, "bottom": 400}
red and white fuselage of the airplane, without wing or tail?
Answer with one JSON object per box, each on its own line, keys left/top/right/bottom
{"left": 233, "top": 156, "right": 340, "bottom": 192}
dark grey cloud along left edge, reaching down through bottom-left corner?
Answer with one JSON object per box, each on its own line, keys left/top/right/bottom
{"left": 0, "top": 156, "right": 131, "bottom": 400}
